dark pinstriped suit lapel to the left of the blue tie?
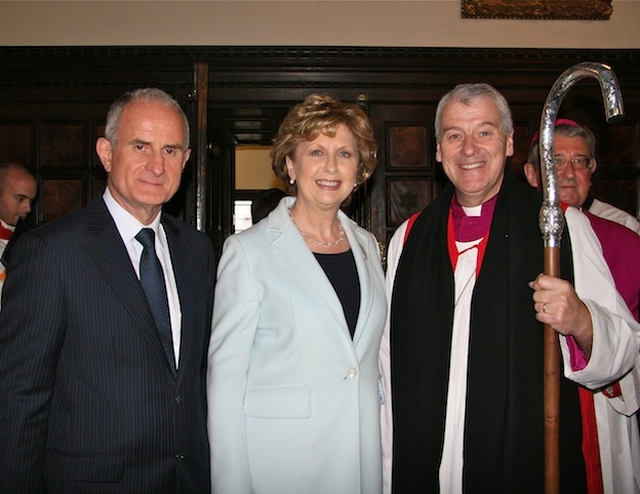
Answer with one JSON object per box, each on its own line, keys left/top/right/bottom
{"left": 87, "top": 197, "right": 175, "bottom": 372}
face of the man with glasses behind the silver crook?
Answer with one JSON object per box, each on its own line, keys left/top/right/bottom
{"left": 553, "top": 132, "right": 597, "bottom": 208}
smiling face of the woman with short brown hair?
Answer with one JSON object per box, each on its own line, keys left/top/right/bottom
{"left": 286, "top": 124, "right": 359, "bottom": 211}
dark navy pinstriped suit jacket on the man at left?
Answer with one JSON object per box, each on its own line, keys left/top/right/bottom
{"left": 0, "top": 197, "right": 215, "bottom": 494}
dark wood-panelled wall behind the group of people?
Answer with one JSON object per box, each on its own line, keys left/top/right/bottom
{"left": 0, "top": 46, "right": 640, "bottom": 251}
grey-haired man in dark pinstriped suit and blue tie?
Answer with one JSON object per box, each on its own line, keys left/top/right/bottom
{"left": 0, "top": 89, "right": 215, "bottom": 494}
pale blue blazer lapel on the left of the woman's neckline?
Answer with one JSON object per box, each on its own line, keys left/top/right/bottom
{"left": 267, "top": 197, "right": 351, "bottom": 338}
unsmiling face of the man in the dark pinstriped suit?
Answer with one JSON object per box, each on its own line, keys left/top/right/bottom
{"left": 96, "top": 100, "right": 191, "bottom": 225}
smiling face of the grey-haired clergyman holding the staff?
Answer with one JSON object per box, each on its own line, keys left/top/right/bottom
{"left": 436, "top": 97, "right": 513, "bottom": 206}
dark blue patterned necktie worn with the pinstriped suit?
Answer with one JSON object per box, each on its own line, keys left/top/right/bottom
{"left": 136, "top": 228, "right": 176, "bottom": 374}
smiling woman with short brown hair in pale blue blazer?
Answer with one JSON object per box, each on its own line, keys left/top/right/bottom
{"left": 207, "top": 94, "right": 386, "bottom": 494}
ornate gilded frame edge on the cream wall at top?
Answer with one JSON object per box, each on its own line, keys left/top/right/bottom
{"left": 461, "top": 0, "right": 613, "bottom": 20}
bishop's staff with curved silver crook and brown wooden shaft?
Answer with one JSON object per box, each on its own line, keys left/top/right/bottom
{"left": 539, "top": 62, "right": 624, "bottom": 494}
